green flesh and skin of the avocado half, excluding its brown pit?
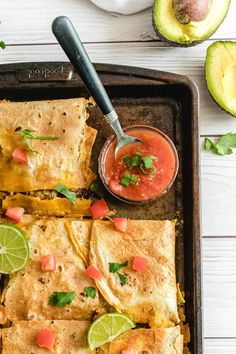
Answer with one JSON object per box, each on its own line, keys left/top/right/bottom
{"left": 153, "top": 0, "right": 231, "bottom": 47}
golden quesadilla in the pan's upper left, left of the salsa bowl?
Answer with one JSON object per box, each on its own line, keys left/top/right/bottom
{"left": 0, "top": 98, "right": 96, "bottom": 192}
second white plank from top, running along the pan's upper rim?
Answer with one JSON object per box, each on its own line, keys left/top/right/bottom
{"left": 0, "top": 42, "right": 235, "bottom": 135}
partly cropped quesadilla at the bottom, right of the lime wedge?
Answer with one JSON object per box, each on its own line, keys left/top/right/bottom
{"left": 100, "top": 326, "right": 183, "bottom": 354}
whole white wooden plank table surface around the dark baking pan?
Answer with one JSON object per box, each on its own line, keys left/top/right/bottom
{"left": 0, "top": 0, "right": 236, "bottom": 354}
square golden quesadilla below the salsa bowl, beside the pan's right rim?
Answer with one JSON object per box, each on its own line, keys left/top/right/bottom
{"left": 90, "top": 220, "right": 179, "bottom": 327}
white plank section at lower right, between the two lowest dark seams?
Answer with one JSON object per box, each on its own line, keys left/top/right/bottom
{"left": 202, "top": 238, "right": 236, "bottom": 338}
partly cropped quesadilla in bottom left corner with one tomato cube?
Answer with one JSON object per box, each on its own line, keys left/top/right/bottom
{"left": 0, "top": 321, "right": 92, "bottom": 354}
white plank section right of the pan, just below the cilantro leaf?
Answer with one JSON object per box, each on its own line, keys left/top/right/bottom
{"left": 201, "top": 139, "right": 236, "bottom": 236}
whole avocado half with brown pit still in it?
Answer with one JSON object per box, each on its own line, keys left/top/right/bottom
{"left": 153, "top": 0, "right": 230, "bottom": 47}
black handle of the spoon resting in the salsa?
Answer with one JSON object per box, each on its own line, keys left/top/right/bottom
{"left": 52, "top": 16, "right": 114, "bottom": 115}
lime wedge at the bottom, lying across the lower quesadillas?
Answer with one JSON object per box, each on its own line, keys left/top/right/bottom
{"left": 87, "top": 313, "right": 135, "bottom": 350}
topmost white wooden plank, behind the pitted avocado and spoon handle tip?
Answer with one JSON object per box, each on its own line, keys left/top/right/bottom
{"left": 1, "top": 0, "right": 236, "bottom": 44}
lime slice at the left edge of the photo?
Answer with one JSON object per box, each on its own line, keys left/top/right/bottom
{"left": 0, "top": 224, "right": 29, "bottom": 274}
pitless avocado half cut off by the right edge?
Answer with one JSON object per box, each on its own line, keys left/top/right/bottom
{"left": 206, "top": 41, "right": 236, "bottom": 116}
